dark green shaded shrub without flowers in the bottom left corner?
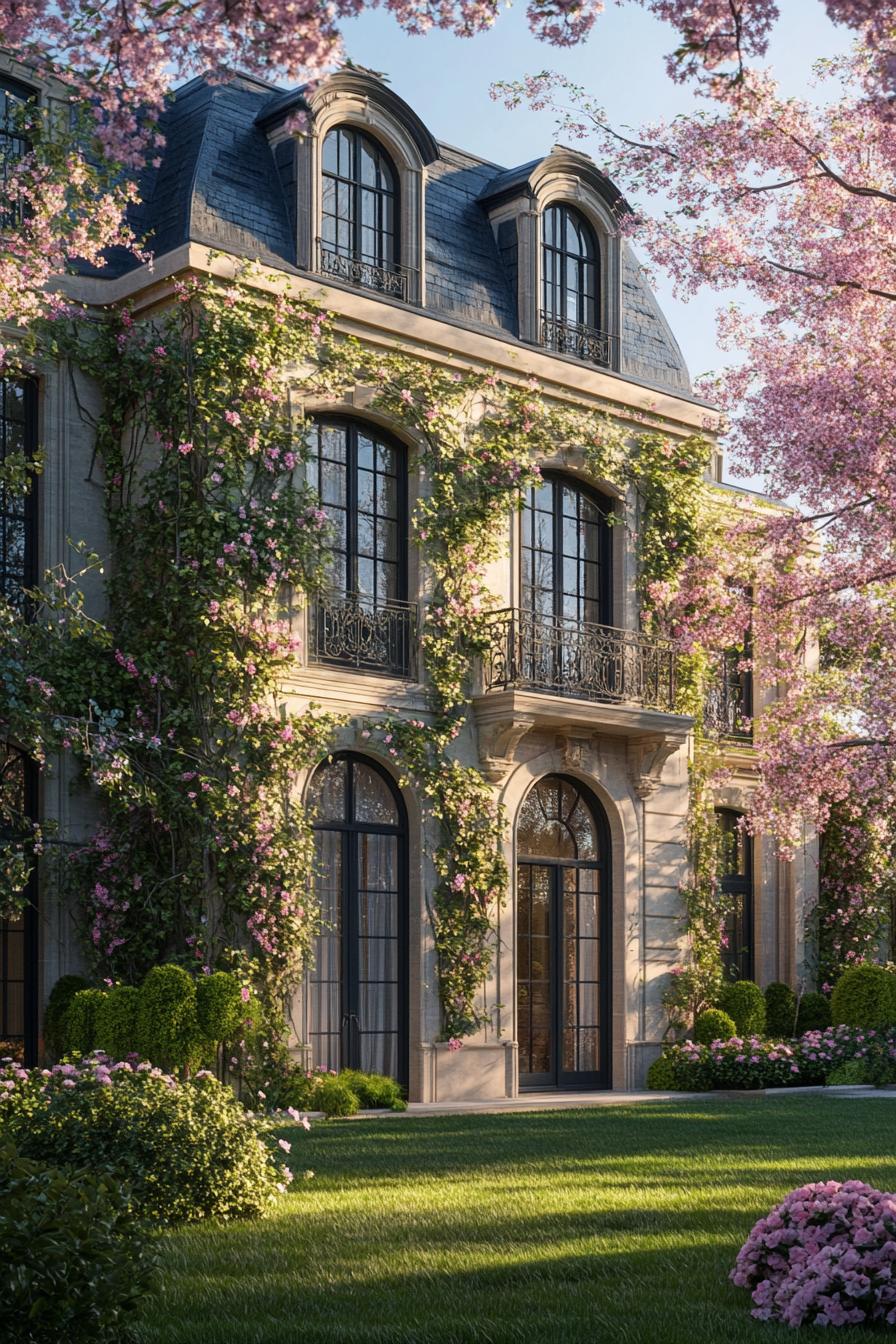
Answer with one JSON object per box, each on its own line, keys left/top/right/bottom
{"left": 0, "top": 1145, "right": 156, "bottom": 1344}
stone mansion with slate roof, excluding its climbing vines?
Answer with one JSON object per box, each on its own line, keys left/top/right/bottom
{"left": 0, "top": 63, "right": 817, "bottom": 1101}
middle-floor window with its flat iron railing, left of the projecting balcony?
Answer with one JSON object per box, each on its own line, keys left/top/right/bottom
{"left": 310, "top": 419, "right": 415, "bottom": 676}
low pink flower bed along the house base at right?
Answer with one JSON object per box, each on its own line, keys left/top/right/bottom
{"left": 654, "top": 1027, "right": 896, "bottom": 1091}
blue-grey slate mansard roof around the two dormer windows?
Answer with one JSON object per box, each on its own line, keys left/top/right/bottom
{"left": 102, "top": 69, "right": 690, "bottom": 395}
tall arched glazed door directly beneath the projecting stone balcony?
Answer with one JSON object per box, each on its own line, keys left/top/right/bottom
{"left": 516, "top": 774, "right": 611, "bottom": 1087}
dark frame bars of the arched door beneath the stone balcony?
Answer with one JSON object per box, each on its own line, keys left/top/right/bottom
{"left": 514, "top": 773, "right": 613, "bottom": 1091}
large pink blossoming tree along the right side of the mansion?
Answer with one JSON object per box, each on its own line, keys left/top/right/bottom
{"left": 496, "top": 0, "right": 896, "bottom": 855}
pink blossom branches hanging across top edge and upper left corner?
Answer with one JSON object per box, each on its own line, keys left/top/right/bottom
{"left": 0, "top": 0, "right": 896, "bottom": 334}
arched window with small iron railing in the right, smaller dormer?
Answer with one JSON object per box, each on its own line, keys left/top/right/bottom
{"left": 541, "top": 204, "right": 610, "bottom": 366}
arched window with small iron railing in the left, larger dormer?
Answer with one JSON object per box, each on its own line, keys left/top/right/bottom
{"left": 320, "top": 126, "right": 397, "bottom": 298}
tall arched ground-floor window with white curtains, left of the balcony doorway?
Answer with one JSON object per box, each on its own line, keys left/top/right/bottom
{"left": 305, "top": 754, "right": 408, "bottom": 1083}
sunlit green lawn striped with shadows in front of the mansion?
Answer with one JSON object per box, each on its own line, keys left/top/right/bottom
{"left": 140, "top": 1095, "right": 896, "bottom": 1344}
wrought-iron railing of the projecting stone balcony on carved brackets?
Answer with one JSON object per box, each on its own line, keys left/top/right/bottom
{"left": 482, "top": 609, "right": 676, "bottom": 714}
